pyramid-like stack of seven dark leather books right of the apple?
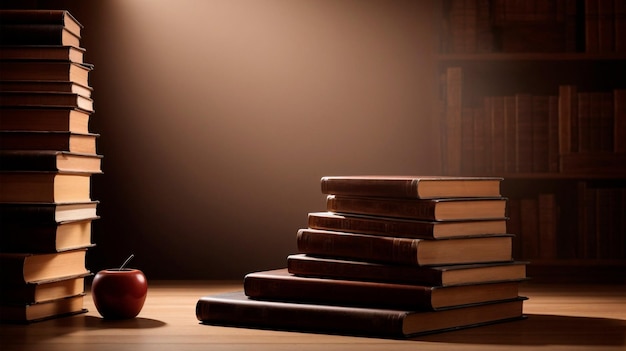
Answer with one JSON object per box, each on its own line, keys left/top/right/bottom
{"left": 196, "top": 176, "right": 527, "bottom": 338}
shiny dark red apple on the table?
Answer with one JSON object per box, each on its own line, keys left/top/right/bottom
{"left": 91, "top": 268, "right": 148, "bottom": 319}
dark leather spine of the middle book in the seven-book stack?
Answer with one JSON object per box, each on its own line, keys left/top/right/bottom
{"left": 296, "top": 229, "right": 419, "bottom": 265}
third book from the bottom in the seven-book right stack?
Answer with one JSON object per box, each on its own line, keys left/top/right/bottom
{"left": 287, "top": 254, "right": 527, "bottom": 286}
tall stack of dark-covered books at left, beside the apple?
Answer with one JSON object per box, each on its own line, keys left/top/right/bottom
{"left": 0, "top": 10, "right": 101, "bottom": 322}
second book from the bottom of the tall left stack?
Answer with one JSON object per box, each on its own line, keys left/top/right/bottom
{"left": 0, "top": 273, "right": 90, "bottom": 305}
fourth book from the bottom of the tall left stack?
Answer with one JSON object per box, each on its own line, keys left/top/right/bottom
{"left": 0, "top": 217, "right": 98, "bottom": 253}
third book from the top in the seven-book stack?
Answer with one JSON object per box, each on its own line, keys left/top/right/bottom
{"left": 308, "top": 210, "right": 507, "bottom": 239}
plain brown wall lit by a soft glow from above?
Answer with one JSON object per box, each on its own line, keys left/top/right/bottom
{"left": 3, "top": 0, "right": 439, "bottom": 279}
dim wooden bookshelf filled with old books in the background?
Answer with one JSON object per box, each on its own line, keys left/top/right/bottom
{"left": 436, "top": 0, "right": 626, "bottom": 283}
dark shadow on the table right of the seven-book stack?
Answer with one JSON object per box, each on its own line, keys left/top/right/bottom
{"left": 410, "top": 314, "right": 626, "bottom": 346}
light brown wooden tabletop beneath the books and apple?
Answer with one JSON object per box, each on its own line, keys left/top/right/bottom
{"left": 0, "top": 281, "right": 626, "bottom": 351}
